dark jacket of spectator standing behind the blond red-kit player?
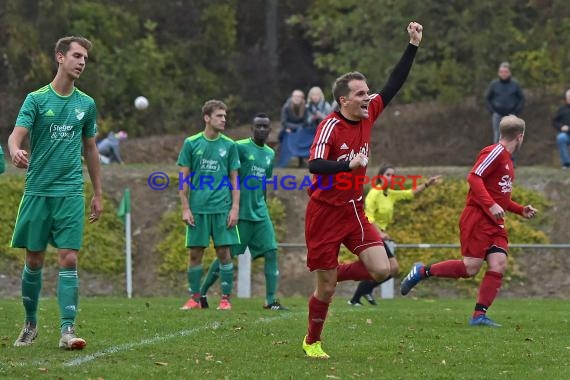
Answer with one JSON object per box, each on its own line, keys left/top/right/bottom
{"left": 485, "top": 78, "right": 525, "bottom": 116}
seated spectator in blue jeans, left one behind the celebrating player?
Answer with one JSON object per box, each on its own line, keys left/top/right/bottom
{"left": 277, "top": 90, "right": 306, "bottom": 168}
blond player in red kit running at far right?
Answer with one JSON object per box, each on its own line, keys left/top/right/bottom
{"left": 400, "top": 115, "right": 537, "bottom": 327}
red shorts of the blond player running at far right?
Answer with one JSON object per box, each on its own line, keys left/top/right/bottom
{"left": 459, "top": 206, "right": 509, "bottom": 259}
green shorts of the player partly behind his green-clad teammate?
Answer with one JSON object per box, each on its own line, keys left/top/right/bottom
{"left": 231, "top": 219, "right": 277, "bottom": 259}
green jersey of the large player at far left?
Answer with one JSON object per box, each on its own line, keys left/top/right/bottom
{"left": 16, "top": 84, "right": 97, "bottom": 197}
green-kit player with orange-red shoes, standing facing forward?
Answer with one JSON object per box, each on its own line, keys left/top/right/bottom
{"left": 178, "top": 100, "right": 240, "bottom": 310}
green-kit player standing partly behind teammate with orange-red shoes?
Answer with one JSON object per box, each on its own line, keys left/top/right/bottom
{"left": 200, "top": 113, "right": 287, "bottom": 310}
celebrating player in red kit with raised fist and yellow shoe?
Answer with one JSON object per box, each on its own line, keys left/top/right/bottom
{"left": 303, "top": 22, "right": 422, "bottom": 359}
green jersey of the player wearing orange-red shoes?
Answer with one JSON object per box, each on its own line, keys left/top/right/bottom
{"left": 177, "top": 132, "right": 240, "bottom": 214}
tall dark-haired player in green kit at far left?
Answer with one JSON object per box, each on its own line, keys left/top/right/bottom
{"left": 8, "top": 37, "right": 103, "bottom": 350}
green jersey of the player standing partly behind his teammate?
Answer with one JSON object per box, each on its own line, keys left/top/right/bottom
{"left": 233, "top": 138, "right": 275, "bottom": 221}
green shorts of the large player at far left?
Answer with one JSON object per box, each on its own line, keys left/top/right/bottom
{"left": 11, "top": 195, "right": 85, "bottom": 252}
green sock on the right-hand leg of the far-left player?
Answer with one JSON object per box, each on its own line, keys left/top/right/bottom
{"left": 57, "top": 268, "right": 79, "bottom": 330}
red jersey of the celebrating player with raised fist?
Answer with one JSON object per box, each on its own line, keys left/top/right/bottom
{"left": 308, "top": 94, "right": 384, "bottom": 205}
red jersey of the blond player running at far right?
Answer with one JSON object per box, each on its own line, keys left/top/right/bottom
{"left": 467, "top": 144, "right": 522, "bottom": 224}
